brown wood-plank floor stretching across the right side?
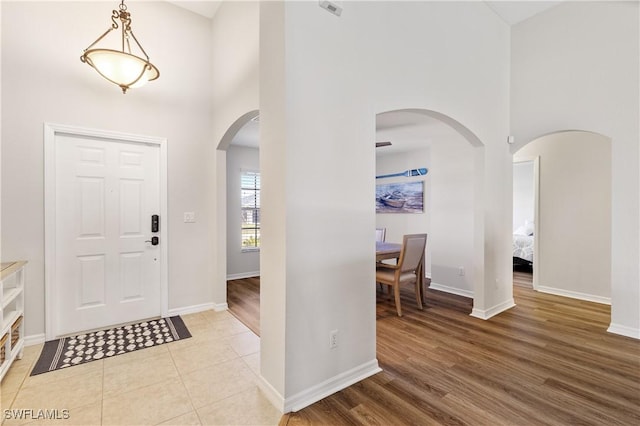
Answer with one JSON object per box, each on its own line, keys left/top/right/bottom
{"left": 229, "top": 273, "right": 640, "bottom": 426}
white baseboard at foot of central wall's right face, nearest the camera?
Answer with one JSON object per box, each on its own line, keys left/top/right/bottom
{"left": 283, "top": 359, "right": 382, "bottom": 413}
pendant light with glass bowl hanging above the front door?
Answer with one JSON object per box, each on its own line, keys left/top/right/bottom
{"left": 80, "top": 0, "right": 160, "bottom": 93}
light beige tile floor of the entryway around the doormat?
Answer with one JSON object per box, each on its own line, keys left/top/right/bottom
{"left": 0, "top": 311, "right": 281, "bottom": 426}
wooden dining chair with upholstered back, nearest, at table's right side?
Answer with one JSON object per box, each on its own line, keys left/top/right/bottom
{"left": 376, "top": 234, "right": 427, "bottom": 317}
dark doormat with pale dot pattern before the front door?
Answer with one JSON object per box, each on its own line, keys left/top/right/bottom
{"left": 31, "top": 316, "right": 191, "bottom": 376}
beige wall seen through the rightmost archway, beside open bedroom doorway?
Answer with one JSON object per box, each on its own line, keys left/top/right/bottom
{"left": 514, "top": 132, "right": 611, "bottom": 303}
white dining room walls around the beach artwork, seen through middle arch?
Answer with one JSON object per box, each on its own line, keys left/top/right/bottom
{"left": 376, "top": 138, "right": 475, "bottom": 297}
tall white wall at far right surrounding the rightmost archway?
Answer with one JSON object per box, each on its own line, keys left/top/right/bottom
{"left": 511, "top": 2, "right": 640, "bottom": 338}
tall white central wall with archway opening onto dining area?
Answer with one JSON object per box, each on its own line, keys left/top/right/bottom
{"left": 260, "top": 2, "right": 512, "bottom": 409}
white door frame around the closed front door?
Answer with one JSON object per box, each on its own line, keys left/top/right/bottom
{"left": 44, "top": 123, "right": 169, "bottom": 340}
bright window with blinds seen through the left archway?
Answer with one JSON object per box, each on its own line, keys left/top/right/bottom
{"left": 240, "top": 170, "right": 260, "bottom": 251}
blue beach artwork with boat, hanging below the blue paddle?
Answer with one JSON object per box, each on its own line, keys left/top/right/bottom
{"left": 376, "top": 181, "right": 424, "bottom": 213}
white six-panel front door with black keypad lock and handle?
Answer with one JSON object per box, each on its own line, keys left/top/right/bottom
{"left": 53, "top": 134, "right": 162, "bottom": 336}
